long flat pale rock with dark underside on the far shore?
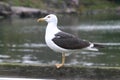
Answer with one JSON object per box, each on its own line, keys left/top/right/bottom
{"left": 11, "top": 6, "right": 48, "bottom": 18}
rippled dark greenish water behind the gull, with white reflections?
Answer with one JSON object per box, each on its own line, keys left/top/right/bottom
{"left": 0, "top": 15, "right": 120, "bottom": 67}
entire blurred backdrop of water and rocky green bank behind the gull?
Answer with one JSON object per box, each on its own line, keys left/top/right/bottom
{"left": 0, "top": 0, "right": 120, "bottom": 67}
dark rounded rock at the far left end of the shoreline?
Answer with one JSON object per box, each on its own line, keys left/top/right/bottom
{"left": 0, "top": 2, "right": 12, "bottom": 18}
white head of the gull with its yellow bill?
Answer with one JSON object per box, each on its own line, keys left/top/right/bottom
{"left": 37, "top": 14, "right": 58, "bottom": 24}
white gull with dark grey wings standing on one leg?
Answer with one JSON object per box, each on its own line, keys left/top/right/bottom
{"left": 37, "top": 14, "right": 102, "bottom": 68}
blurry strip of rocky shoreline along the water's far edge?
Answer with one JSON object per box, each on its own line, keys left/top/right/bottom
{"left": 0, "top": 2, "right": 120, "bottom": 18}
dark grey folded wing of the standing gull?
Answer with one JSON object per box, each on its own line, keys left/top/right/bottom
{"left": 52, "top": 32, "right": 90, "bottom": 49}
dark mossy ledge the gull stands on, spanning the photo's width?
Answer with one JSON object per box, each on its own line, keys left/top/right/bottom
{"left": 0, "top": 63, "right": 120, "bottom": 80}
